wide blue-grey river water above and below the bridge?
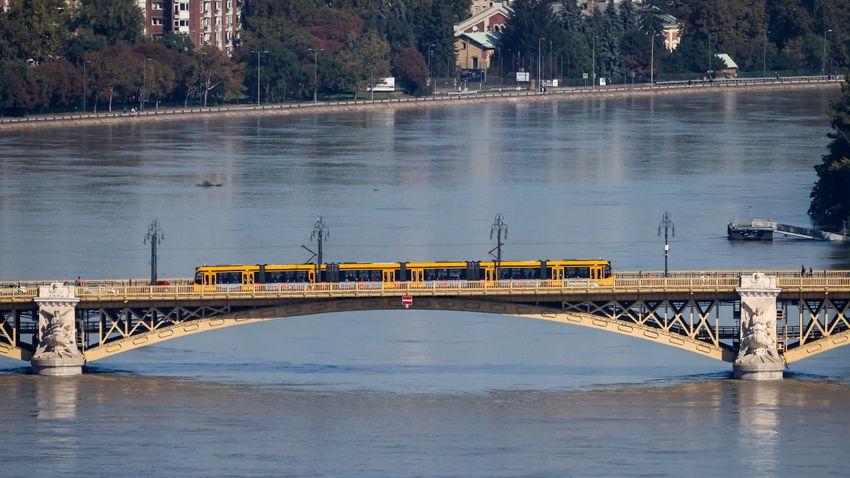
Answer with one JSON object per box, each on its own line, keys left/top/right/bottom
{"left": 0, "top": 90, "right": 850, "bottom": 477}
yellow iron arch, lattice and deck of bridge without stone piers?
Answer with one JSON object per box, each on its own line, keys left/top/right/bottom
{"left": 0, "top": 273, "right": 850, "bottom": 364}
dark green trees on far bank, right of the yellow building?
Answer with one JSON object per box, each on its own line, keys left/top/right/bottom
{"left": 500, "top": 0, "right": 850, "bottom": 82}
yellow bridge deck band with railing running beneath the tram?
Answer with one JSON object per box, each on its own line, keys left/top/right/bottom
{"left": 0, "top": 271, "right": 850, "bottom": 305}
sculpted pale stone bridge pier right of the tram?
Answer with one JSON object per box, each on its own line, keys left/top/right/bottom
{"left": 732, "top": 272, "right": 785, "bottom": 380}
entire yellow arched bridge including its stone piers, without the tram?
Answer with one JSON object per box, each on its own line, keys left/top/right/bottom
{"left": 0, "top": 271, "right": 850, "bottom": 380}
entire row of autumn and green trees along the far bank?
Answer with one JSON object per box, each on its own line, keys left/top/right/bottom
{"left": 0, "top": 0, "right": 850, "bottom": 114}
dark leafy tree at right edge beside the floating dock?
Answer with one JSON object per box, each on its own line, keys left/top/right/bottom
{"left": 809, "top": 75, "right": 850, "bottom": 229}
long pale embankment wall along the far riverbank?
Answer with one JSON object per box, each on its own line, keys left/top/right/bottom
{"left": 0, "top": 77, "right": 843, "bottom": 131}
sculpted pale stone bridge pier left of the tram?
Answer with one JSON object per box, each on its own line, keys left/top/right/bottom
{"left": 30, "top": 284, "right": 85, "bottom": 376}
